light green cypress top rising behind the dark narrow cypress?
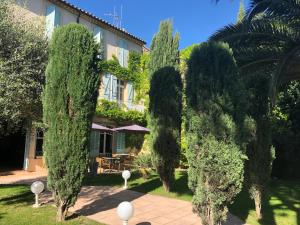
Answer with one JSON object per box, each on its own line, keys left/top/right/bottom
{"left": 149, "top": 20, "right": 179, "bottom": 76}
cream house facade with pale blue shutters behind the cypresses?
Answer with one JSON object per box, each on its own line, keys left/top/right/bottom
{"left": 16, "top": 0, "right": 147, "bottom": 171}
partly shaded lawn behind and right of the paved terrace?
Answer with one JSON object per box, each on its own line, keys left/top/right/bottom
{"left": 85, "top": 171, "right": 300, "bottom": 225}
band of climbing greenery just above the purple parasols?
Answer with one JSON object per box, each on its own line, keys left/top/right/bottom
{"left": 96, "top": 99, "right": 147, "bottom": 126}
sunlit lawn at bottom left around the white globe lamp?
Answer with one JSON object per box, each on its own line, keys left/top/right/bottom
{"left": 0, "top": 185, "right": 103, "bottom": 225}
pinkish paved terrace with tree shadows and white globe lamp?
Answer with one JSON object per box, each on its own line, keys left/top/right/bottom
{"left": 0, "top": 172, "right": 244, "bottom": 225}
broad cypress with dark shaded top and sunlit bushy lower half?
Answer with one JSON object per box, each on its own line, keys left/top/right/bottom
{"left": 186, "top": 42, "right": 247, "bottom": 225}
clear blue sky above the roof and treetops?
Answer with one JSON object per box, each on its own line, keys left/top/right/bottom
{"left": 68, "top": 0, "right": 249, "bottom": 49}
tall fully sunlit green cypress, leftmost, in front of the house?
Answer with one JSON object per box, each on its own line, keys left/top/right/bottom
{"left": 43, "top": 24, "right": 99, "bottom": 221}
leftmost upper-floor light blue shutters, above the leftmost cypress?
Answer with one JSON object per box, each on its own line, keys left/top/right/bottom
{"left": 45, "top": 4, "right": 61, "bottom": 38}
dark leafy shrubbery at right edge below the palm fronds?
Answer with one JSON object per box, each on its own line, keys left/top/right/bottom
{"left": 271, "top": 81, "right": 300, "bottom": 179}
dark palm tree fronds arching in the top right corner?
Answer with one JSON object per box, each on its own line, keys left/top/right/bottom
{"left": 210, "top": 0, "right": 300, "bottom": 100}
